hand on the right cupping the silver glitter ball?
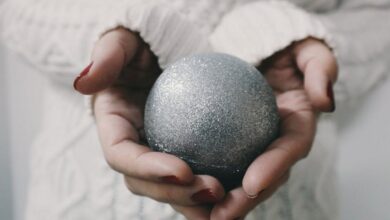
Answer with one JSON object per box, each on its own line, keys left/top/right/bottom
{"left": 204, "top": 38, "right": 337, "bottom": 219}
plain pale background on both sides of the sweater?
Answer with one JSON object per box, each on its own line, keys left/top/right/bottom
{"left": 0, "top": 42, "right": 390, "bottom": 220}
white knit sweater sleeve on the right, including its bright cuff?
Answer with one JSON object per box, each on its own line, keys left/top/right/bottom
{"left": 210, "top": 0, "right": 390, "bottom": 102}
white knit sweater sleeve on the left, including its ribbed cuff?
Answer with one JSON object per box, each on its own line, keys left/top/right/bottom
{"left": 0, "top": 0, "right": 213, "bottom": 86}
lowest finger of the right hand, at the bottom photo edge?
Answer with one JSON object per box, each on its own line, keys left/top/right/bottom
{"left": 211, "top": 172, "right": 289, "bottom": 220}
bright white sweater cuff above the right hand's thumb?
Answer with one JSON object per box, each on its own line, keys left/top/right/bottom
{"left": 210, "top": 1, "right": 334, "bottom": 66}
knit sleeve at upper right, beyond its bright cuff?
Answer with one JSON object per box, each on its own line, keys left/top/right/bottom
{"left": 318, "top": 0, "right": 390, "bottom": 101}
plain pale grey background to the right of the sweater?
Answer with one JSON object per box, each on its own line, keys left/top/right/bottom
{"left": 338, "top": 81, "right": 390, "bottom": 220}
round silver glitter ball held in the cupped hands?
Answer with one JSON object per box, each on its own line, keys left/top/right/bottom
{"left": 145, "top": 53, "right": 279, "bottom": 188}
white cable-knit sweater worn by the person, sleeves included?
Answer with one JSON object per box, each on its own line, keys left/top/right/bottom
{"left": 0, "top": 0, "right": 390, "bottom": 220}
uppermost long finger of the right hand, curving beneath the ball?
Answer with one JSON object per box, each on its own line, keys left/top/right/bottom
{"left": 243, "top": 92, "right": 315, "bottom": 196}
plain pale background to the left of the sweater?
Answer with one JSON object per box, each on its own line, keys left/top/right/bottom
{"left": 0, "top": 50, "right": 44, "bottom": 220}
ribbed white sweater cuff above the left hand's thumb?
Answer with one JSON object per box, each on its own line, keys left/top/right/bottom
{"left": 92, "top": 1, "right": 210, "bottom": 69}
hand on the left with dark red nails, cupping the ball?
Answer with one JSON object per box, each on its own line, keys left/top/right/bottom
{"left": 75, "top": 29, "right": 224, "bottom": 211}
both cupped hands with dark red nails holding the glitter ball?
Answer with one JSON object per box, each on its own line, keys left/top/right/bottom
{"left": 74, "top": 28, "right": 337, "bottom": 219}
